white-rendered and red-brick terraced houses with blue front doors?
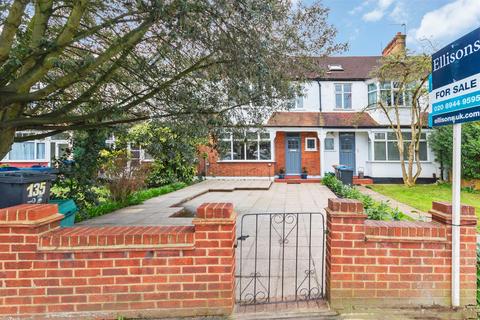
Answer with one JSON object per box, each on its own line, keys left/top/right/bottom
{"left": 199, "top": 33, "right": 439, "bottom": 182}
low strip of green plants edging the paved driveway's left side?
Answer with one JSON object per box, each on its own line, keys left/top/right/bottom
{"left": 76, "top": 182, "right": 187, "bottom": 222}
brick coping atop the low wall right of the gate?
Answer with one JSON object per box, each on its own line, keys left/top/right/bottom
{"left": 365, "top": 220, "right": 447, "bottom": 242}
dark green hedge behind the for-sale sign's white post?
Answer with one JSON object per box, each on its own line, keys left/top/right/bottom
{"left": 429, "top": 122, "right": 480, "bottom": 179}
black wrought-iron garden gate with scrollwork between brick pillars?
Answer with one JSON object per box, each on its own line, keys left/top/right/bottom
{"left": 236, "top": 213, "right": 325, "bottom": 304}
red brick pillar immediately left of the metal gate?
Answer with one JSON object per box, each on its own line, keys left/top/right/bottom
{"left": 193, "top": 203, "right": 236, "bottom": 314}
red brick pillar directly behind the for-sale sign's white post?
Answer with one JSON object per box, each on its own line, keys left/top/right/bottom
{"left": 429, "top": 202, "right": 477, "bottom": 306}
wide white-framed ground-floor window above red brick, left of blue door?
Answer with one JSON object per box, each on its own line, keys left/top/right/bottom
{"left": 219, "top": 132, "right": 272, "bottom": 161}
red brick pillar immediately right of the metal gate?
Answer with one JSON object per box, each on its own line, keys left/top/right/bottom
{"left": 325, "top": 198, "right": 367, "bottom": 304}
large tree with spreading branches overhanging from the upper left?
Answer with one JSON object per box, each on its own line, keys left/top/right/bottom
{"left": 0, "top": 0, "right": 344, "bottom": 159}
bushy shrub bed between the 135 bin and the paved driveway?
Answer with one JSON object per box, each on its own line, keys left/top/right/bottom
{"left": 51, "top": 122, "right": 202, "bottom": 222}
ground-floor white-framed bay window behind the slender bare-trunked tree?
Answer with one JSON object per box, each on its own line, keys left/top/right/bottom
{"left": 373, "top": 132, "right": 428, "bottom": 161}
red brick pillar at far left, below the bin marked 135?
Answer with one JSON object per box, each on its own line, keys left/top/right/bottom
{"left": 0, "top": 204, "right": 63, "bottom": 318}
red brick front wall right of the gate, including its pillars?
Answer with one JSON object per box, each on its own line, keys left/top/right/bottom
{"left": 326, "top": 199, "right": 477, "bottom": 308}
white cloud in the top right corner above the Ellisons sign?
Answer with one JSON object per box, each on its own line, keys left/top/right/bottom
{"left": 412, "top": 0, "right": 480, "bottom": 43}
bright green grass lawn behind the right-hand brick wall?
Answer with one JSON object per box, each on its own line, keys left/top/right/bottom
{"left": 370, "top": 184, "right": 480, "bottom": 229}
